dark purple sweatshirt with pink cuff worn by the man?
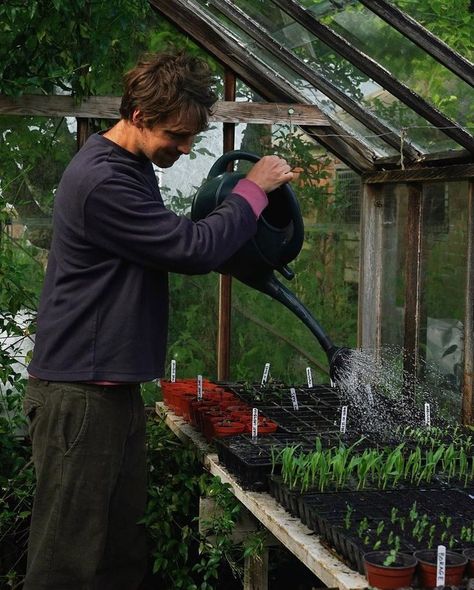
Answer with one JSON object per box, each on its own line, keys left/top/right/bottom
{"left": 28, "top": 134, "right": 266, "bottom": 382}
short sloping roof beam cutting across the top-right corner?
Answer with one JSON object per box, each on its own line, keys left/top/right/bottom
{"left": 360, "top": 0, "right": 474, "bottom": 86}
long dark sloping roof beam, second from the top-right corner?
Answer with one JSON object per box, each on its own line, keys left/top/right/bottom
{"left": 272, "top": 0, "right": 474, "bottom": 153}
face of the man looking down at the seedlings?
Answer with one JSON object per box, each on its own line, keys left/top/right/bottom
{"left": 138, "top": 111, "right": 195, "bottom": 168}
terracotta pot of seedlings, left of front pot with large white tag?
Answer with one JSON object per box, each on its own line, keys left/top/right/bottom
{"left": 364, "top": 551, "right": 416, "bottom": 590}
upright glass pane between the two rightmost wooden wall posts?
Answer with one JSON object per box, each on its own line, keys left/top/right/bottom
{"left": 421, "top": 182, "right": 468, "bottom": 412}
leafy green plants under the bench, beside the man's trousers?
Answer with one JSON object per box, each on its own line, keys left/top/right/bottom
{"left": 143, "top": 420, "right": 262, "bottom": 590}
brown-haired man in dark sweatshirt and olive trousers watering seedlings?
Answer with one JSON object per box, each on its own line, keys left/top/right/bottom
{"left": 24, "top": 53, "right": 293, "bottom": 590}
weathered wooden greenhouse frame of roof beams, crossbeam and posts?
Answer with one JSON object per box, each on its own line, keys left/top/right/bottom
{"left": 0, "top": 0, "right": 474, "bottom": 424}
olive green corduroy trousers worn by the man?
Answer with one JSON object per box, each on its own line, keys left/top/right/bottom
{"left": 24, "top": 379, "right": 146, "bottom": 590}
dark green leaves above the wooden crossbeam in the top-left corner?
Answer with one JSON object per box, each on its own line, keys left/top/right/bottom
{"left": 0, "top": 0, "right": 149, "bottom": 96}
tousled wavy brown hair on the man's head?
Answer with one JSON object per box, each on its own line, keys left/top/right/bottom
{"left": 120, "top": 51, "right": 217, "bottom": 133}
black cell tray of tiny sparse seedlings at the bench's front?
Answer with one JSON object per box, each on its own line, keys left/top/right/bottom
{"left": 270, "top": 484, "right": 474, "bottom": 573}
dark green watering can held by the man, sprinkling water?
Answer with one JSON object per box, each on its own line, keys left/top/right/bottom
{"left": 191, "top": 150, "right": 350, "bottom": 381}
